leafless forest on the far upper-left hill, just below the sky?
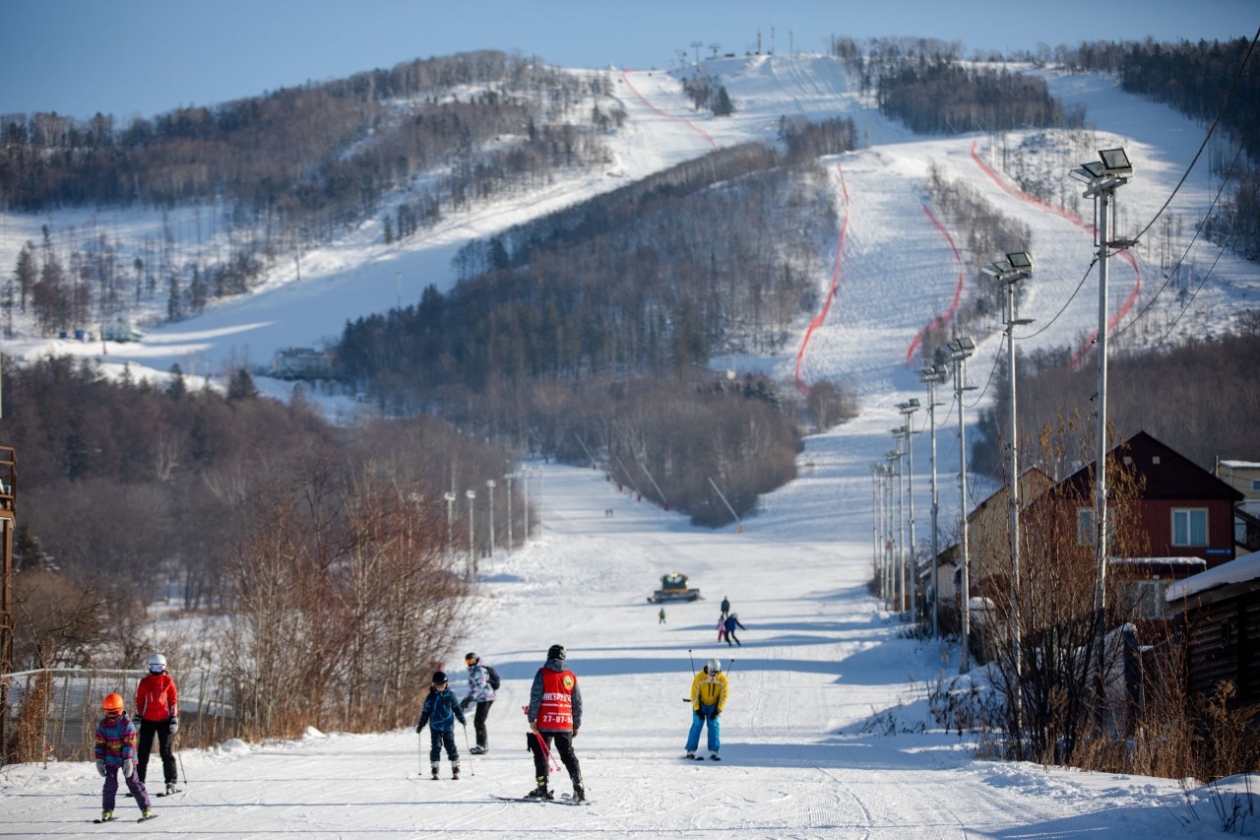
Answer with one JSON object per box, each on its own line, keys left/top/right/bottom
{"left": 0, "top": 52, "right": 621, "bottom": 335}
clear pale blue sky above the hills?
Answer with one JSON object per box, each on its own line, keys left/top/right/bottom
{"left": 0, "top": 0, "right": 1260, "bottom": 118}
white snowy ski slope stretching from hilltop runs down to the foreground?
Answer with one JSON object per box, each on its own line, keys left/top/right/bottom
{"left": 0, "top": 57, "right": 1257, "bottom": 840}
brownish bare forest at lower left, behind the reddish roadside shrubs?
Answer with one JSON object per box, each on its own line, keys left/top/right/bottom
{"left": 0, "top": 356, "right": 516, "bottom": 670}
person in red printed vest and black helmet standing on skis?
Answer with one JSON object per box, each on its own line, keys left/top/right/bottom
{"left": 525, "top": 645, "right": 586, "bottom": 802}
